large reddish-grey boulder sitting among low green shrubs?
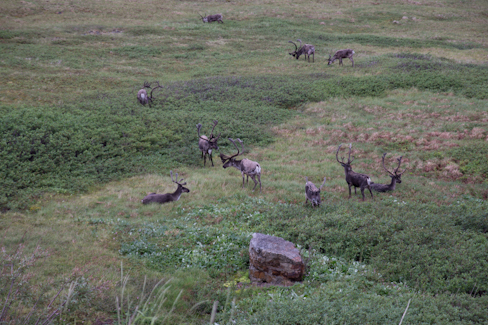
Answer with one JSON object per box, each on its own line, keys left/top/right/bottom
{"left": 249, "top": 233, "right": 305, "bottom": 286}
